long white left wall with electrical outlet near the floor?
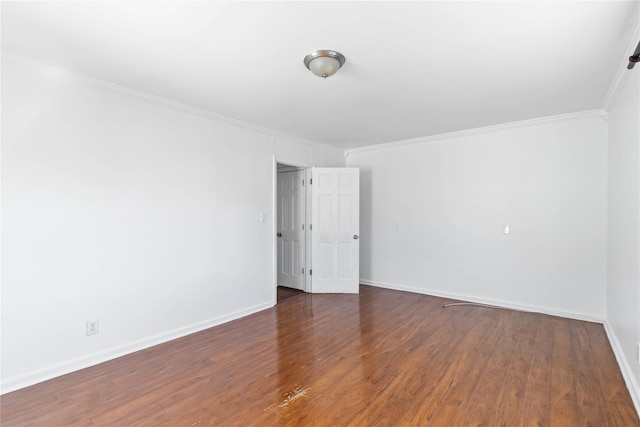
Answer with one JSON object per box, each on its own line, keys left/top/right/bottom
{"left": 2, "top": 56, "right": 344, "bottom": 392}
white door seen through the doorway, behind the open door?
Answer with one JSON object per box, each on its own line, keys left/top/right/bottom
{"left": 277, "top": 171, "right": 305, "bottom": 290}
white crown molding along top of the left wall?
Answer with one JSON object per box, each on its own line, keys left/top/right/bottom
{"left": 2, "top": 50, "right": 344, "bottom": 153}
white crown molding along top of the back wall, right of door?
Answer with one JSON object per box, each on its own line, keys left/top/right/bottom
{"left": 345, "top": 110, "right": 609, "bottom": 157}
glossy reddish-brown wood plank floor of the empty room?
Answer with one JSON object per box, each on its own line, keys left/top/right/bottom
{"left": 2, "top": 286, "right": 640, "bottom": 427}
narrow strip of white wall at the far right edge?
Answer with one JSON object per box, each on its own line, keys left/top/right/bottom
{"left": 607, "top": 67, "right": 640, "bottom": 410}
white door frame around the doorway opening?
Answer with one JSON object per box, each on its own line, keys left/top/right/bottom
{"left": 271, "top": 156, "right": 315, "bottom": 305}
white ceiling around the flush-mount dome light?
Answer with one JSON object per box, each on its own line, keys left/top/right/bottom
{"left": 2, "top": 1, "right": 640, "bottom": 148}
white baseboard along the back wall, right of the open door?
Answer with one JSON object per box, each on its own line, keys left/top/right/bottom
{"left": 360, "top": 279, "right": 605, "bottom": 323}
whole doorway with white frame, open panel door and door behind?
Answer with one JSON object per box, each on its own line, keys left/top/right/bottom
{"left": 273, "top": 162, "right": 360, "bottom": 303}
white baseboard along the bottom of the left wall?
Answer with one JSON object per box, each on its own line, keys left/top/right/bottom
{"left": 0, "top": 303, "right": 273, "bottom": 394}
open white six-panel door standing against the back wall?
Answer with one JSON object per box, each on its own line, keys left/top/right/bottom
{"left": 309, "top": 168, "right": 360, "bottom": 293}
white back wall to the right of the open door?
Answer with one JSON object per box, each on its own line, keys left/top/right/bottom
{"left": 347, "top": 113, "right": 607, "bottom": 319}
